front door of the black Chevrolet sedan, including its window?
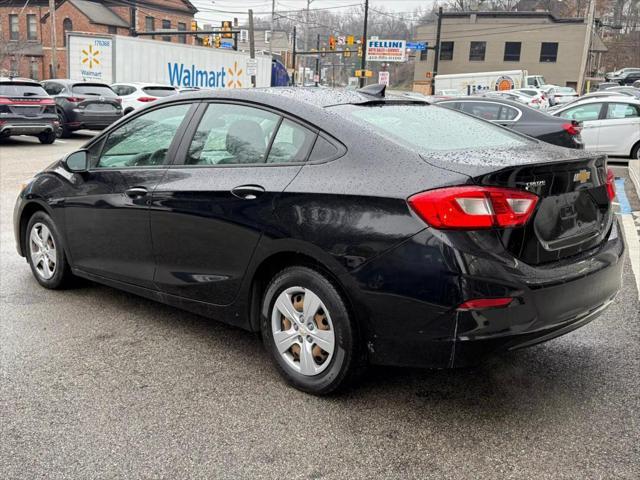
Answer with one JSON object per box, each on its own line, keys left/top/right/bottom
{"left": 65, "top": 103, "right": 191, "bottom": 287}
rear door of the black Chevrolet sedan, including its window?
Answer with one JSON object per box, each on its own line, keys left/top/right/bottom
{"left": 151, "top": 102, "right": 317, "bottom": 305}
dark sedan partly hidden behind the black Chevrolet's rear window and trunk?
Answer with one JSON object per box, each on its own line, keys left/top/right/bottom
{"left": 437, "top": 97, "right": 584, "bottom": 148}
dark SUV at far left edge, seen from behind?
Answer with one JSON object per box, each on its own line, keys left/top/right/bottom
{"left": 0, "top": 77, "right": 58, "bottom": 144}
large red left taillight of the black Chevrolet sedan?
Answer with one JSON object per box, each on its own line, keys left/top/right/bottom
{"left": 408, "top": 186, "right": 538, "bottom": 230}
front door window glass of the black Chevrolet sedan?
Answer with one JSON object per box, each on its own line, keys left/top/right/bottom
{"left": 96, "top": 104, "right": 191, "bottom": 168}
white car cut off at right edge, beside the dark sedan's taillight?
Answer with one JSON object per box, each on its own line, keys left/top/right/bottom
{"left": 553, "top": 95, "right": 640, "bottom": 159}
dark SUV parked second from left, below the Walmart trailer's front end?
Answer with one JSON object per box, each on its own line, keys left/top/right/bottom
{"left": 42, "top": 79, "right": 122, "bottom": 138}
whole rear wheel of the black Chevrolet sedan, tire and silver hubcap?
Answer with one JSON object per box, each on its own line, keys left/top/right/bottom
{"left": 261, "top": 266, "right": 364, "bottom": 395}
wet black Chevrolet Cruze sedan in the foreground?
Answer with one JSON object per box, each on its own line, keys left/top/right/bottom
{"left": 14, "top": 86, "right": 625, "bottom": 394}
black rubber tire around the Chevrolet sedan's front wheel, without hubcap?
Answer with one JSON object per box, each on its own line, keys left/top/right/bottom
{"left": 24, "top": 211, "right": 73, "bottom": 290}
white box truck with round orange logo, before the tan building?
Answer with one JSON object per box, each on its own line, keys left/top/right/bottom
{"left": 434, "top": 70, "right": 545, "bottom": 95}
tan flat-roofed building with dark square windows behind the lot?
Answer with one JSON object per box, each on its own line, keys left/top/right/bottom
{"left": 413, "top": 11, "right": 606, "bottom": 93}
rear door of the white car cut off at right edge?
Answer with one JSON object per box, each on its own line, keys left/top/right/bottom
{"left": 598, "top": 102, "right": 640, "bottom": 155}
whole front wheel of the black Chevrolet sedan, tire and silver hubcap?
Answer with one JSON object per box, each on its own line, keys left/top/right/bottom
{"left": 25, "top": 212, "right": 73, "bottom": 290}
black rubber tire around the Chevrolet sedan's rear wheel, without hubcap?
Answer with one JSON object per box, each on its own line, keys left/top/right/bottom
{"left": 260, "top": 266, "right": 366, "bottom": 395}
